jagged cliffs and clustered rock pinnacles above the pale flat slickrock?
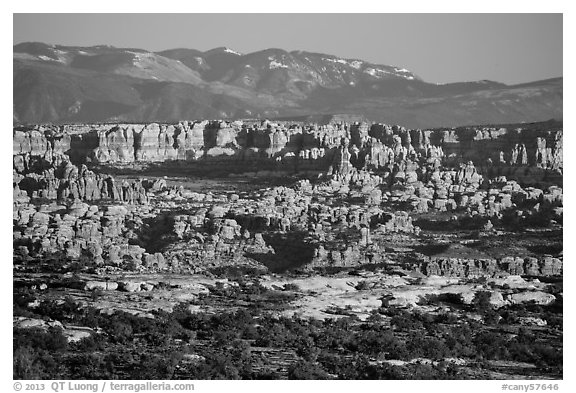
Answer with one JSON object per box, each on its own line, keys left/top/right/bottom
{"left": 13, "top": 121, "right": 563, "bottom": 278}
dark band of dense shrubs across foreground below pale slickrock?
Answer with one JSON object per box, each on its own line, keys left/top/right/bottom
{"left": 14, "top": 290, "right": 562, "bottom": 379}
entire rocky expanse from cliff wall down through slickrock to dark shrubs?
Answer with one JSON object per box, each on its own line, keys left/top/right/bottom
{"left": 13, "top": 118, "right": 563, "bottom": 377}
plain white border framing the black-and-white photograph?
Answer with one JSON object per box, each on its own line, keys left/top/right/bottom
{"left": 0, "top": 0, "right": 576, "bottom": 392}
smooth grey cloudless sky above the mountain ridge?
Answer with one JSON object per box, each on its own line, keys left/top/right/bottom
{"left": 13, "top": 14, "right": 562, "bottom": 83}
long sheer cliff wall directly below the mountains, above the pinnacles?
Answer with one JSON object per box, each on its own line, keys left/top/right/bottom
{"left": 14, "top": 121, "right": 563, "bottom": 177}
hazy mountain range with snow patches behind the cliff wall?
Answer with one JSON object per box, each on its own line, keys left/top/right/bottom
{"left": 13, "top": 42, "right": 563, "bottom": 128}
